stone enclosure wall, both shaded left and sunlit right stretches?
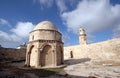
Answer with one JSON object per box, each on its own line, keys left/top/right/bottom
{"left": 0, "top": 38, "right": 120, "bottom": 61}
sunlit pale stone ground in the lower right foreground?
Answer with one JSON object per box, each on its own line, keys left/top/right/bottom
{"left": 64, "top": 60, "right": 120, "bottom": 78}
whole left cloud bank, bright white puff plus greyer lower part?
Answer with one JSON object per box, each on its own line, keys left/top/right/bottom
{"left": 0, "top": 22, "right": 34, "bottom": 44}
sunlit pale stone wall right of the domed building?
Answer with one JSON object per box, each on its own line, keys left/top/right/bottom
{"left": 64, "top": 38, "right": 120, "bottom": 60}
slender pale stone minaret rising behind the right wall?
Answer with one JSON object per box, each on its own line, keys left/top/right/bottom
{"left": 79, "top": 28, "right": 87, "bottom": 45}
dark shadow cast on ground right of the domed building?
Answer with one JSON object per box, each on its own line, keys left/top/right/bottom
{"left": 64, "top": 58, "right": 91, "bottom": 65}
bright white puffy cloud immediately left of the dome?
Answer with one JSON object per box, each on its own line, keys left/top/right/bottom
{"left": 11, "top": 22, "right": 34, "bottom": 38}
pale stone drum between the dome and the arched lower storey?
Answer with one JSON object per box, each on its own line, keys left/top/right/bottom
{"left": 29, "top": 30, "right": 62, "bottom": 41}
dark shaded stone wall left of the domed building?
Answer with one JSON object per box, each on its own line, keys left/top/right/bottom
{"left": 0, "top": 48, "right": 26, "bottom": 61}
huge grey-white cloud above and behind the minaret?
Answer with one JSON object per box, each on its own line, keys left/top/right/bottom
{"left": 61, "top": 0, "right": 120, "bottom": 40}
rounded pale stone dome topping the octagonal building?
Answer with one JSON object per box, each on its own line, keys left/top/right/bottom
{"left": 34, "top": 21, "right": 58, "bottom": 31}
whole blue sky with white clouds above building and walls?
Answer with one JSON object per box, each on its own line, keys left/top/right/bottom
{"left": 0, "top": 0, "right": 120, "bottom": 48}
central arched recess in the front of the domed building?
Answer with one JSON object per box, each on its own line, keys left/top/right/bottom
{"left": 40, "top": 45, "right": 53, "bottom": 67}
